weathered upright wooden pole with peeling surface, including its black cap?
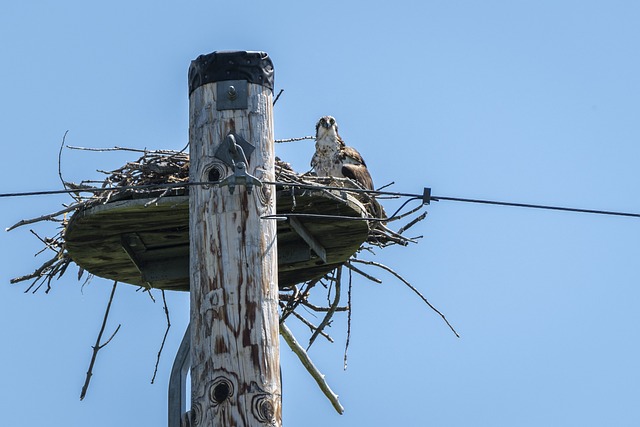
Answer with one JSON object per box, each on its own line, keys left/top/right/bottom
{"left": 189, "top": 51, "right": 282, "bottom": 427}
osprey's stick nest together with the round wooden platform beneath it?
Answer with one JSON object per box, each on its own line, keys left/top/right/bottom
{"left": 7, "top": 147, "right": 446, "bottom": 352}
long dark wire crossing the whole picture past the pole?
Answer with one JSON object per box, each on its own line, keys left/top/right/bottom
{"left": 0, "top": 181, "right": 640, "bottom": 218}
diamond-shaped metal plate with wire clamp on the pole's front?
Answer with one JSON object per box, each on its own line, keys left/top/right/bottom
{"left": 215, "top": 132, "right": 262, "bottom": 194}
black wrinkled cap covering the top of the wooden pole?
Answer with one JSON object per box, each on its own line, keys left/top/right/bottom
{"left": 189, "top": 50, "right": 273, "bottom": 95}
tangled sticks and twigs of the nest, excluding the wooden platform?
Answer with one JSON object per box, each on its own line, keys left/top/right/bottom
{"left": 7, "top": 146, "right": 457, "bottom": 412}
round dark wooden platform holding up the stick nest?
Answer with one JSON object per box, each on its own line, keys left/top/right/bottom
{"left": 64, "top": 182, "right": 370, "bottom": 291}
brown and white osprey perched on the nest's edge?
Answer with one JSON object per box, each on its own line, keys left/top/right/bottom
{"left": 311, "top": 116, "right": 373, "bottom": 190}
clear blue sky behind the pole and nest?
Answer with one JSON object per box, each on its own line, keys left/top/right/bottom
{"left": 0, "top": 0, "right": 640, "bottom": 427}
